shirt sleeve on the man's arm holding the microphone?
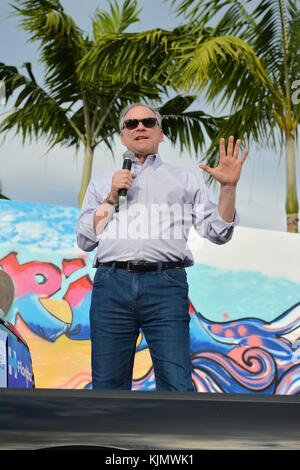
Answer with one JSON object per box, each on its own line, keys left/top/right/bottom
{"left": 76, "top": 180, "right": 104, "bottom": 251}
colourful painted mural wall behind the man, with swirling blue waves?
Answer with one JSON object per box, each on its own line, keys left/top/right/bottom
{"left": 0, "top": 200, "right": 300, "bottom": 395}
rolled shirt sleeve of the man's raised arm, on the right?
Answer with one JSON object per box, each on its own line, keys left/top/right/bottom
{"left": 193, "top": 174, "right": 240, "bottom": 245}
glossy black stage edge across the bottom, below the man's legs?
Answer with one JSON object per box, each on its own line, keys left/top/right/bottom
{"left": 0, "top": 389, "right": 300, "bottom": 455}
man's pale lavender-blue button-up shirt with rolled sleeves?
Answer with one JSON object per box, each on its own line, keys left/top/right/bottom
{"left": 76, "top": 154, "right": 239, "bottom": 266}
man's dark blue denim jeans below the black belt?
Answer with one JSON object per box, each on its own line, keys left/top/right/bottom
{"left": 90, "top": 265, "right": 194, "bottom": 391}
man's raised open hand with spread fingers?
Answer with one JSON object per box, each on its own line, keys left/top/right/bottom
{"left": 199, "top": 136, "right": 249, "bottom": 186}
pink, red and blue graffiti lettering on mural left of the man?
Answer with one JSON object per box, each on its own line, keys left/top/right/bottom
{"left": 0, "top": 252, "right": 92, "bottom": 342}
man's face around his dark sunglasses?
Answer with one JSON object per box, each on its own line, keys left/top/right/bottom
{"left": 121, "top": 106, "right": 164, "bottom": 158}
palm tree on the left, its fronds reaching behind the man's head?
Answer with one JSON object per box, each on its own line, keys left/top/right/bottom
{"left": 0, "top": 0, "right": 227, "bottom": 206}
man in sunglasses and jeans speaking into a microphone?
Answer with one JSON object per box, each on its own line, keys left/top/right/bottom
{"left": 77, "top": 104, "right": 248, "bottom": 391}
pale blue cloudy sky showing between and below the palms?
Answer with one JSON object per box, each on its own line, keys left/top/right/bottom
{"left": 0, "top": 0, "right": 300, "bottom": 231}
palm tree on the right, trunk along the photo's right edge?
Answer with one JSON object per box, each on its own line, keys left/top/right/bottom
{"left": 172, "top": 0, "right": 300, "bottom": 233}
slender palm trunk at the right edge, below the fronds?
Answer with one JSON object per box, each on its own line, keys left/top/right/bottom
{"left": 285, "top": 131, "right": 299, "bottom": 233}
